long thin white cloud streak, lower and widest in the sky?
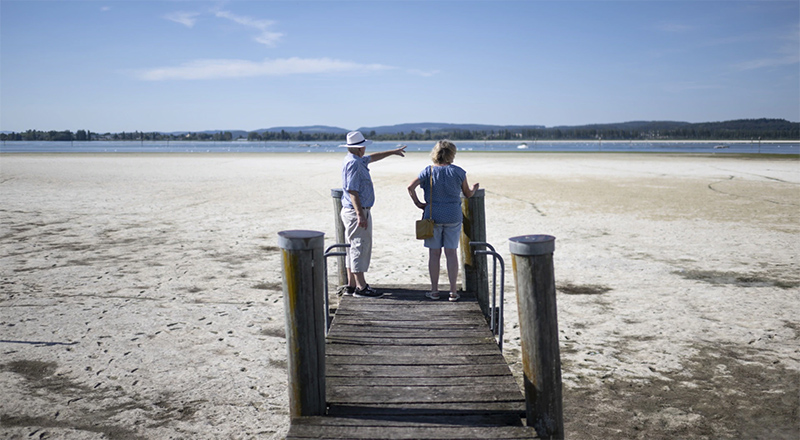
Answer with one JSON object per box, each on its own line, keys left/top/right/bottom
{"left": 134, "top": 57, "right": 393, "bottom": 81}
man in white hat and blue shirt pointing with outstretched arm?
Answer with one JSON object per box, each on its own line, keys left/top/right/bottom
{"left": 339, "top": 131, "right": 406, "bottom": 298}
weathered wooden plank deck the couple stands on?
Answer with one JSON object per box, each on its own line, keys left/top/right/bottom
{"left": 286, "top": 286, "right": 536, "bottom": 439}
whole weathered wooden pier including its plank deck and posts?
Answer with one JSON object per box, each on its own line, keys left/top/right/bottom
{"left": 278, "top": 189, "right": 564, "bottom": 439}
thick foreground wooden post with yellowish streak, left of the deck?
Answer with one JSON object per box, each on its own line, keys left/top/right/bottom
{"left": 278, "top": 231, "right": 327, "bottom": 418}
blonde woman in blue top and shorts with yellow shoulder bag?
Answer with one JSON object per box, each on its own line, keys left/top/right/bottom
{"left": 408, "top": 141, "right": 478, "bottom": 301}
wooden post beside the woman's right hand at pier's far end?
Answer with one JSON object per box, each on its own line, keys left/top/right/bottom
{"left": 459, "top": 188, "right": 491, "bottom": 319}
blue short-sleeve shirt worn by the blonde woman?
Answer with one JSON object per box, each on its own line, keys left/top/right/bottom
{"left": 419, "top": 164, "right": 467, "bottom": 223}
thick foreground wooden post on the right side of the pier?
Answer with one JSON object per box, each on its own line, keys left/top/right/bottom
{"left": 509, "top": 235, "right": 564, "bottom": 439}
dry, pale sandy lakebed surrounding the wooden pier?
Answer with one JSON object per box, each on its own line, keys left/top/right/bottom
{"left": 0, "top": 153, "right": 800, "bottom": 440}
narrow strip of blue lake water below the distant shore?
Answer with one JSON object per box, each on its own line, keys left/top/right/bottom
{"left": 0, "top": 141, "right": 800, "bottom": 154}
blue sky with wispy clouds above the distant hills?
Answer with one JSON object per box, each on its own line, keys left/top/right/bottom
{"left": 0, "top": 0, "right": 800, "bottom": 133}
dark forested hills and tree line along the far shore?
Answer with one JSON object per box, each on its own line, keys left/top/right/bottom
{"left": 0, "top": 119, "right": 800, "bottom": 141}
